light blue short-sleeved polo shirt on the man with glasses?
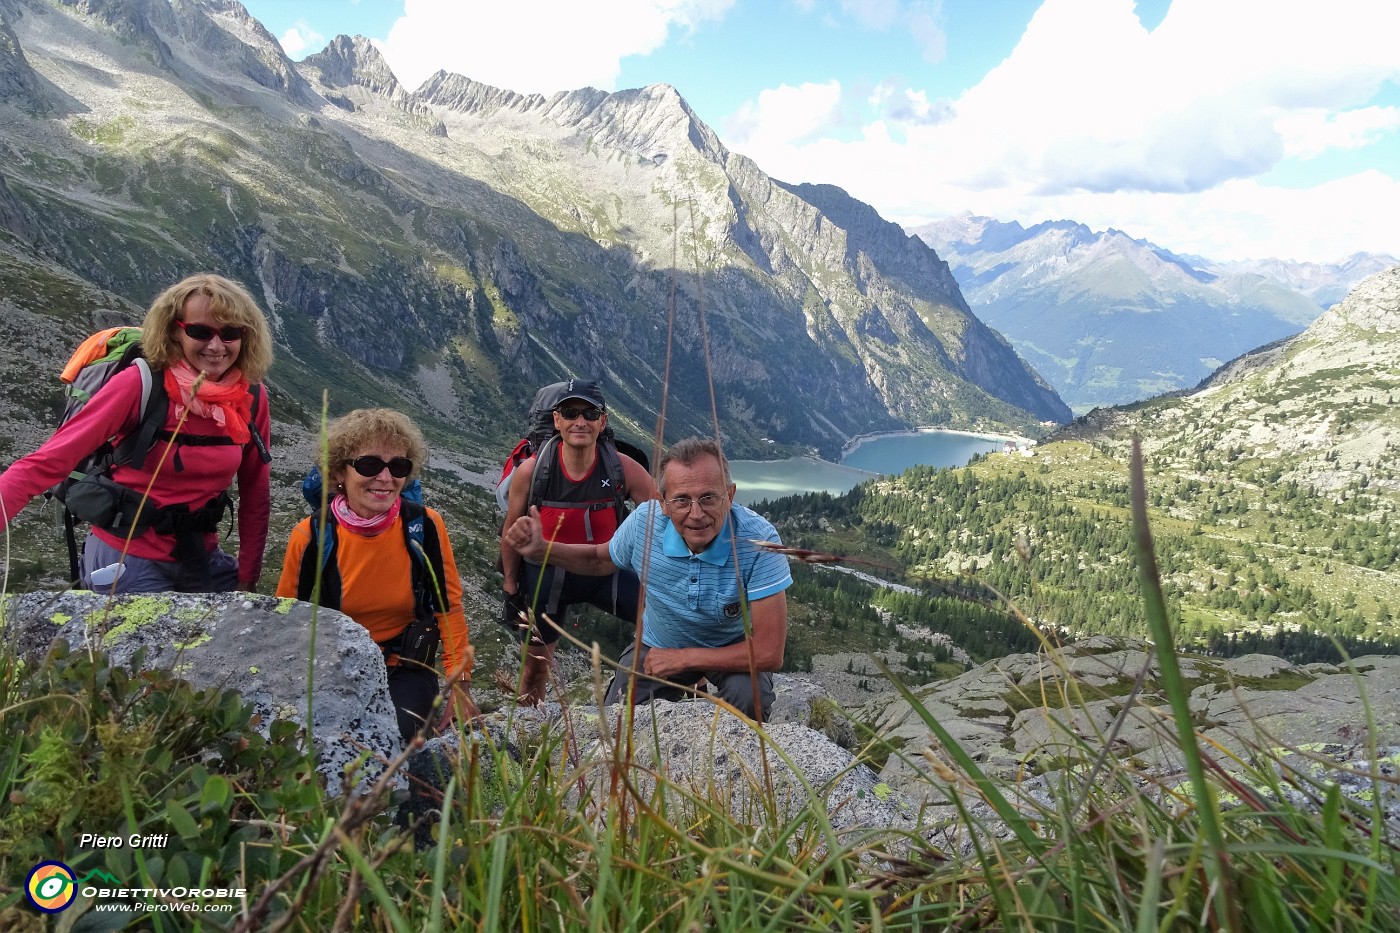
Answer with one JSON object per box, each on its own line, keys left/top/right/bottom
{"left": 608, "top": 499, "right": 792, "bottom": 649}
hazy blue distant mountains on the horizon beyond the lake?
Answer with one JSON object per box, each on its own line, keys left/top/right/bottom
{"left": 910, "top": 214, "right": 1396, "bottom": 412}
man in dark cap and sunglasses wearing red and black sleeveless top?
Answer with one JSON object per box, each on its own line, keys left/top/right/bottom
{"left": 501, "top": 380, "right": 657, "bottom": 697}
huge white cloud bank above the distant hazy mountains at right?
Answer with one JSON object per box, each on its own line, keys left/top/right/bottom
{"left": 725, "top": 0, "right": 1400, "bottom": 259}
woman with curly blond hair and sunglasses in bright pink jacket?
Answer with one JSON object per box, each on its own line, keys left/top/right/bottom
{"left": 0, "top": 273, "right": 272, "bottom": 593}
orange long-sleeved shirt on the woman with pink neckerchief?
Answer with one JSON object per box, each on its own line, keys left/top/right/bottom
{"left": 277, "top": 509, "right": 476, "bottom": 681}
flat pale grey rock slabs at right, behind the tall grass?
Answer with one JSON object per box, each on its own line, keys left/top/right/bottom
{"left": 855, "top": 636, "right": 1400, "bottom": 804}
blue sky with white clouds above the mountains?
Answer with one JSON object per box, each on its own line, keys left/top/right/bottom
{"left": 235, "top": 0, "right": 1400, "bottom": 262}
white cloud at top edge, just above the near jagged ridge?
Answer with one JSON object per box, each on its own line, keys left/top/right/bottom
{"left": 381, "top": 0, "right": 734, "bottom": 94}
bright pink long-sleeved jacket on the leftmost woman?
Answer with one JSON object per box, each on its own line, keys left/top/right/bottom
{"left": 0, "top": 367, "right": 272, "bottom": 586}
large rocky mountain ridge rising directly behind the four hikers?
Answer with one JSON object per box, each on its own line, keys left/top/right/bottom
{"left": 0, "top": 0, "right": 1071, "bottom": 481}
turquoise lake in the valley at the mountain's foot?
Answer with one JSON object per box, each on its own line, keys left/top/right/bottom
{"left": 729, "top": 431, "right": 1005, "bottom": 506}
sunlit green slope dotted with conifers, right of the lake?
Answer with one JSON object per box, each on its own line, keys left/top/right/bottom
{"left": 769, "top": 265, "right": 1400, "bottom": 660}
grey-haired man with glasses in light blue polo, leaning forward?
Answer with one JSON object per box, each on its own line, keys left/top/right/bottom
{"left": 507, "top": 437, "right": 792, "bottom": 717}
